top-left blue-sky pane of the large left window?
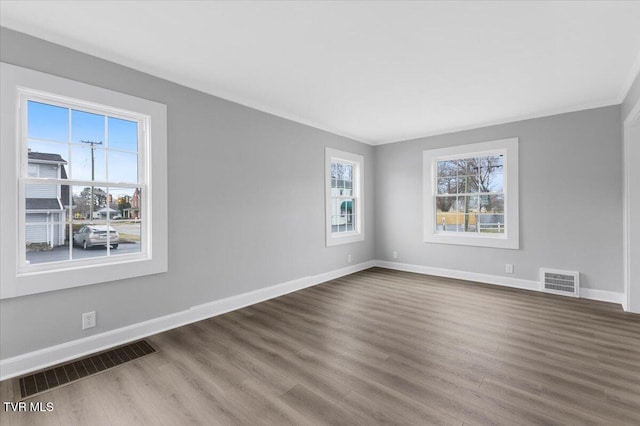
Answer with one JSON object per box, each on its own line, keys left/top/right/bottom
{"left": 27, "top": 101, "right": 69, "bottom": 142}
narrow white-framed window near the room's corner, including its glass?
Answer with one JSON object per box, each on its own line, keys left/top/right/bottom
{"left": 325, "top": 148, "right": 364, "bottom": 246}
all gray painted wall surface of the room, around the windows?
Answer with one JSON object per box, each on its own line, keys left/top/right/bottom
{"left": 0, "top": 28, "right": 640, "bottom": 359}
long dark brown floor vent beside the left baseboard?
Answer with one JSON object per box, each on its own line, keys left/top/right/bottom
{"left": 18, "top": 340, "right": 156, "bottom": 398}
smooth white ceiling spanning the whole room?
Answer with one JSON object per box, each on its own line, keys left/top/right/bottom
{"left": 0, "top": 0, "right": 640, "bottom": 145}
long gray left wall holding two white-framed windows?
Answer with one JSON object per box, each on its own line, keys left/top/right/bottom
{"left": 0, "top": 28, "right": 374, "bottom": 359}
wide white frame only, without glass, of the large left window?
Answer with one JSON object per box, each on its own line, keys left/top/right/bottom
{"left": 0, "top": 63, "right": 168, "bottom": 299}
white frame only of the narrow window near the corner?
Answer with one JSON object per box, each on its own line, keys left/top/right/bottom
{"left": 325, "top": 147, "right": 364, "bottom": 247}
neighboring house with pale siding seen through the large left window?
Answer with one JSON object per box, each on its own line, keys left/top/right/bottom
{"left": 25, "top": 151, "right": 69, "bottom": 247}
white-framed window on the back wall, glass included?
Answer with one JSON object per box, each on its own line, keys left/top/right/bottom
{"left": 424, "top": 138, "right": 519, "bottom": 249}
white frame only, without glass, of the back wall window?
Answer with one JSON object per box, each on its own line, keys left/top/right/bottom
{"left": 423, "top": 138, "right": 520, "bottom": 250}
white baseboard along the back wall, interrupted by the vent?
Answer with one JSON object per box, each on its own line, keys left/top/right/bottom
{"left": 375, "top": 260, "right": 625, "bottom": 305}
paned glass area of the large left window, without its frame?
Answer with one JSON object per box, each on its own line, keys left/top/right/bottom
{"left": 19, "top": 96, "right": 148, "bottom": 272}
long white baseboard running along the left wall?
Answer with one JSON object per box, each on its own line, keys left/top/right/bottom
{"left": 0, "top": 261, "right": 375, "bottom": 380}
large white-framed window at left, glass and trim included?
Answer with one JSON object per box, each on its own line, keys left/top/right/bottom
{"left": 0, "top": 63, "right": 167, "bottom": 298}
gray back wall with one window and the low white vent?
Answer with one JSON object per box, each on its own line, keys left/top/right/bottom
{"left": 375, "top": 105, "right": 623, "bottom": 292}
